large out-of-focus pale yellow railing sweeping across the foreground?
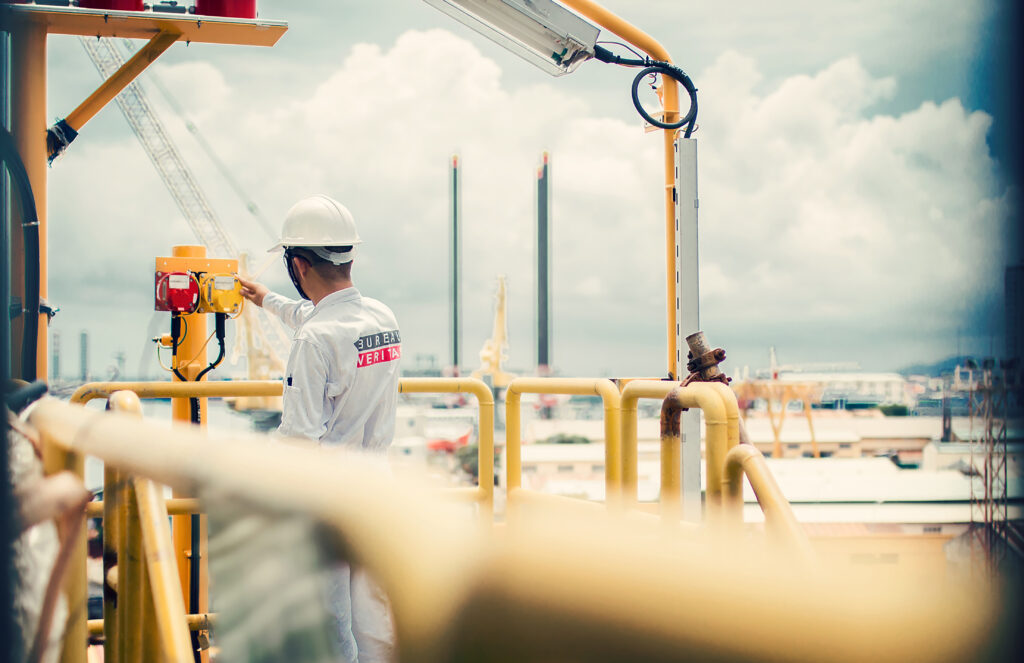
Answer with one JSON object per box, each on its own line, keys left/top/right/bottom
{"left": 24, "top": 399, "right": 1013, "bottom": 662}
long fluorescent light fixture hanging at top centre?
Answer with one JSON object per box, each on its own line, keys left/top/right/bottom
{"left": 424, "top": 0, "right": 600, "bottom": 76}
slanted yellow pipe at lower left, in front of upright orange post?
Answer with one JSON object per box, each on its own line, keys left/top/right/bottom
{"left": 134, "top": 478, "right": 193, "bottom": 663}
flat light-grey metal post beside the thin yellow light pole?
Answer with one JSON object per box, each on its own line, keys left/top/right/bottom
{"left": 676, "top": 137, "right": 702, "bottom": 522}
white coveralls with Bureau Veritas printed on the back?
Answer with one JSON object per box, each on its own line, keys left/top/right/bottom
{"left": 263, "top": 288, "right": 401, "bottom": 663}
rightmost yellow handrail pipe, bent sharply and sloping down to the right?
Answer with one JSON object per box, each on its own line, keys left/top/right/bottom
{"left": 722, "top": 445, "right": 814, "bottom": 560}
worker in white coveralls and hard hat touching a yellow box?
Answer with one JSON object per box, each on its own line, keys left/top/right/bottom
{"left": 239, "top": 196, "right": 401, "bottom": 663}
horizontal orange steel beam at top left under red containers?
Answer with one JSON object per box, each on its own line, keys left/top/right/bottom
{"left": 0, "top": 4, "right": 288, "bottom": 46}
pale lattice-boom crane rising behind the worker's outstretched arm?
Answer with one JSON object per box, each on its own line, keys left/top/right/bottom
{"left": 79, "top": 37, "right": 289, "bottom": 393}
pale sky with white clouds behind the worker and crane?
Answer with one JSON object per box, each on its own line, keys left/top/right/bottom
{"left": 36, "top": 0, "right": 1018, "bottom": 376}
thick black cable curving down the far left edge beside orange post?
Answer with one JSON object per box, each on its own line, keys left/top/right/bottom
{"left": 0, "top": 120, "right": 39, "bottom": 382}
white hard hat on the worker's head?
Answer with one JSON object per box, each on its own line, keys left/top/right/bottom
{"left": 268, "top": 194, "right": 362, "bottom": 262}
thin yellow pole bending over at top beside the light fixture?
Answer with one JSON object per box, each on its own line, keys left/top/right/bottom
{"left": 563, "top": 0, "right": 682, "bottom": 379}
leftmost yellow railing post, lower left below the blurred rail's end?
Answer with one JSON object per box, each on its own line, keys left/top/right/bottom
{"left": 43, "top": 436, "right": 89, "bottom": 663}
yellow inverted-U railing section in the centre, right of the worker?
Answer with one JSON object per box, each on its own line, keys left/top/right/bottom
{"left": 505, "top": 377, "right": 623, "bottom": 504}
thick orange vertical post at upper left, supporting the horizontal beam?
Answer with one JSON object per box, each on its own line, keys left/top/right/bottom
{"left": 10, "top": 16, "right": 48, "bottom": 379}
